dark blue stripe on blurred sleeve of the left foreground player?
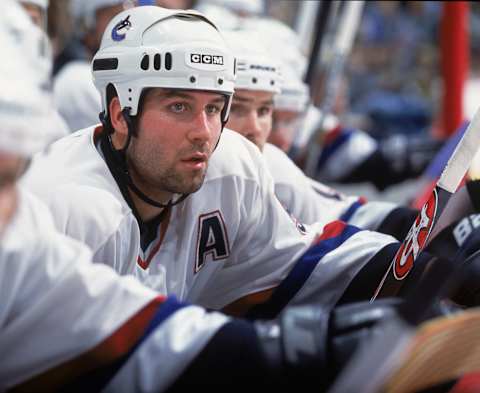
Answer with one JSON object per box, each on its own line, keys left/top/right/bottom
{"left": 64, "top": 296, "right": 188, "bottom": 392}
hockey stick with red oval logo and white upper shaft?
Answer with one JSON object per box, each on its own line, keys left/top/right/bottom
{"left": 371, "top": 108, "right": 480, "bottom": 301}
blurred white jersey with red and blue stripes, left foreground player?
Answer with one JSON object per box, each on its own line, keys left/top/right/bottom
{"left": 0, "top": 188, "right": 229, "bottom": 392}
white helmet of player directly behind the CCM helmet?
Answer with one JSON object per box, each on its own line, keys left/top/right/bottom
{"left": 224, "top": 30, "right": 282, "bottom": 94}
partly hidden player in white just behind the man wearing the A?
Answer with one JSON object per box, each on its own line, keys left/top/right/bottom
{"left": 226, "top": 30, "right": 417, "bottom": 239}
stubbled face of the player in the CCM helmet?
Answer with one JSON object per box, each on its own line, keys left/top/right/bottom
{"left": 128, "top": 88, "right": 225, "bottom": 200}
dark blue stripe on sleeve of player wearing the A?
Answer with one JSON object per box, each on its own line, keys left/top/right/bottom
{"left": 246, "top": 225, "right": 360, "bottom": 319}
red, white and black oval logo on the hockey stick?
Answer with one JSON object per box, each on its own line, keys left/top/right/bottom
{"left": 393, "top": 189, "right": 438, "bottom": 280}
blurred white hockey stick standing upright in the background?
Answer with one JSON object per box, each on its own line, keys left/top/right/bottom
{"left": 305, "top": 1, "right": 364, "bottom": 177}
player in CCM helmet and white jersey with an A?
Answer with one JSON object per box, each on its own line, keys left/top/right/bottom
{"left": 20, "top": 6, "right": 464, "bottom": 317}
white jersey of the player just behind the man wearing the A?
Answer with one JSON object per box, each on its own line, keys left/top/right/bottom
{"left": 263, "top": 143, "right": 406, "bottom": 230}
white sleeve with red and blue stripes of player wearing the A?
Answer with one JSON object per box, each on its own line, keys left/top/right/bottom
{"left": 193, "top": 141, "right": 395, "bottom": 310}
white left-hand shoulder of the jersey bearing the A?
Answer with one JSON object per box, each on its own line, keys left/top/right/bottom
{"left": 22, "top": 129, "right": 131, "bottom": 249}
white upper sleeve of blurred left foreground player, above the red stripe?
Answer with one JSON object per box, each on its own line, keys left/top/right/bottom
{"left": 0, "top": 194, "right": 156, "bottom": 386}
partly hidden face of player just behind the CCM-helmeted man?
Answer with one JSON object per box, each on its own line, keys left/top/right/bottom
{"left": 227, "top": 90, "right": 273, "bottom": 150}
